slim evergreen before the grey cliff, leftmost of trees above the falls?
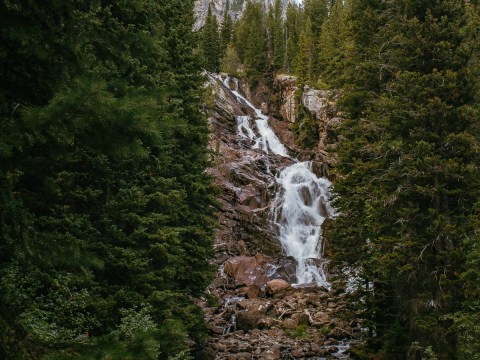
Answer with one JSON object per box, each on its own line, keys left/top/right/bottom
{"left": 202, "top": 5, "right": 221, "bottom": 72}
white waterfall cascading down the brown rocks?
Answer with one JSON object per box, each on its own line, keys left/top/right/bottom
{"left": 224, "top": 77, "right": 334, "bottom": 287}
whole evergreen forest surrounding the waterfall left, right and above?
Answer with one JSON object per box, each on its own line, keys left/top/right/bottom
{"left": 0, "top": 0, "right": 480, "bottom": 360}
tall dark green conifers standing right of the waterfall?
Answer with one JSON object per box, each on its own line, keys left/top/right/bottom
{"left": 332, "top": 0, "right": 480, "bottom": 359}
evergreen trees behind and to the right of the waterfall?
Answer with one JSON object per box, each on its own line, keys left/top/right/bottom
{"left": 198, "top": 0, "right": 480, "bottom": 360}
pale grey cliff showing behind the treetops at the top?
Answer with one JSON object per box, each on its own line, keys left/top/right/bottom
{"left": 194, "top": 0, "right": 292, "bottom": 31}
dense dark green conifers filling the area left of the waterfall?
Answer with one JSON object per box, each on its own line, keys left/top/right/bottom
{"left": 0, "top": 1, "right": 215, "bottom": 359}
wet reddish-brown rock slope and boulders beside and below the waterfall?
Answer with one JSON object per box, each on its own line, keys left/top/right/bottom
{"left": 196, "top": 75, "right": 361, "bottom": 360}
